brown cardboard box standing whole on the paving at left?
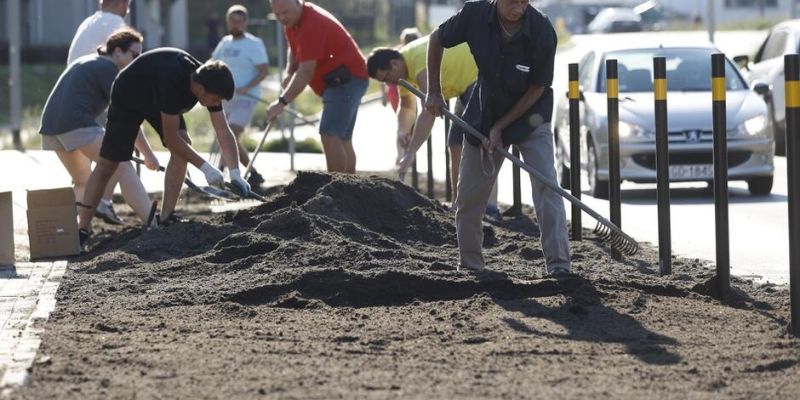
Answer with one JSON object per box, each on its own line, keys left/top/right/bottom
{"left": 28, "top": 188, "right": 80, "bottom": 259}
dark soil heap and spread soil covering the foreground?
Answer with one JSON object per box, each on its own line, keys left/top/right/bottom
{"left": 16, "top": 173, "right": 800, "bottom": 398}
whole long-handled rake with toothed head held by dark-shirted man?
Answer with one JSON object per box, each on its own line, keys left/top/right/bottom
{"left": 398, "top": 79, "right": 639, "bottom": 256}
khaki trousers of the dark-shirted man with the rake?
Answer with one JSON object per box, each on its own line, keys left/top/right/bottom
{"left": 456, "top": 124, "right": 570, "bottom": 272}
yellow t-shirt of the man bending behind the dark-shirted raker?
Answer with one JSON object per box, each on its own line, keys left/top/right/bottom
{"left": 399, "top": 36, "right": 478, "bottom": 99}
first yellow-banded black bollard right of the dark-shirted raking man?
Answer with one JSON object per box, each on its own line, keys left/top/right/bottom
{"left": 569, "top": 64, "right": 583, "bottom": 240}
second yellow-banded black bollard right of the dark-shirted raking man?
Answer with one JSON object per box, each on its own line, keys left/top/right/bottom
{"left": 606, "top": 60, "right": 622, "bottom": 260}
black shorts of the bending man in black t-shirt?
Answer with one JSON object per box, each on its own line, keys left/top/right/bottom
{"left": 100, "top": 103, "right": 186, "bottom": 162}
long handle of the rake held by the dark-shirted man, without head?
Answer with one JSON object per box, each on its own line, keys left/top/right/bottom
{"left": 398, "top": 79, "right": 636, "bottom": 250}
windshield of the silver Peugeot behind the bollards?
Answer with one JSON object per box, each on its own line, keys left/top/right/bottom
{"left": 597, "top": 49, "right": 747, "bottom": 93}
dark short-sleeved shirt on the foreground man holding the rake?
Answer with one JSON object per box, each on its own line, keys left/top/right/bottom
{"left": 439, "top": 0, "right": 557, "bottom": 144}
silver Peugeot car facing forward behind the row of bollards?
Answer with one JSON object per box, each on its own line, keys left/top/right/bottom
{"left": 554, "top": 44, "right": 775, "bottom": 198}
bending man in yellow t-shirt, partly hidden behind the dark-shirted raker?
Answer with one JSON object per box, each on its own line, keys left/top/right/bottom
{"left": 367, "top": 36, "right": 501, "bottom": 219}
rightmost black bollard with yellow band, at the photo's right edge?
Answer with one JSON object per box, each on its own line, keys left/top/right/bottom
{"left": 784, "top": 54, "right": 800, "bottom": 336}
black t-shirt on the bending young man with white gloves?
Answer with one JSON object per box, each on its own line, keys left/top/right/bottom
{"left": 111, "top": 47, "right": 222, "bottom": 116}
